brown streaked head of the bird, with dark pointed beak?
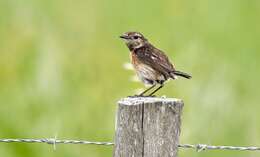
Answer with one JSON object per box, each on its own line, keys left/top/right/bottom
{"left": 120, "top": 32, "right": 148, "bottom": 50}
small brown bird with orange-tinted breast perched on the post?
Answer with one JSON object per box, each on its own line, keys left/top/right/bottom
{"left": 120, "top": 32, "right": 191, "bottom": 96}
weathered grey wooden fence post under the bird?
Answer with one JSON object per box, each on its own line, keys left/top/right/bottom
{"left": 114, "top": 97, "right": 183, "bottom": 157}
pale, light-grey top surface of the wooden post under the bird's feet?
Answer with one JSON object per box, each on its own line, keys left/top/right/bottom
{"left": 118, "top": 97, "right": 183, "bottom": 105}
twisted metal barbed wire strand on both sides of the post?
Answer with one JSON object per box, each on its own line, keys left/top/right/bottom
{"left": 0, "top": 137, "right": 260, "bottom": 152}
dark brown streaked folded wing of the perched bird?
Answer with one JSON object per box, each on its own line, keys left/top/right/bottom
{"left": 136, "top": 46, "right": 175, "bottom": 77}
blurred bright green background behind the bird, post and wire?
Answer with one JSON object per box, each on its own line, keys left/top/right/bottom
{"left": 0, "top": 0, "right": 260, "bottom": 157}
